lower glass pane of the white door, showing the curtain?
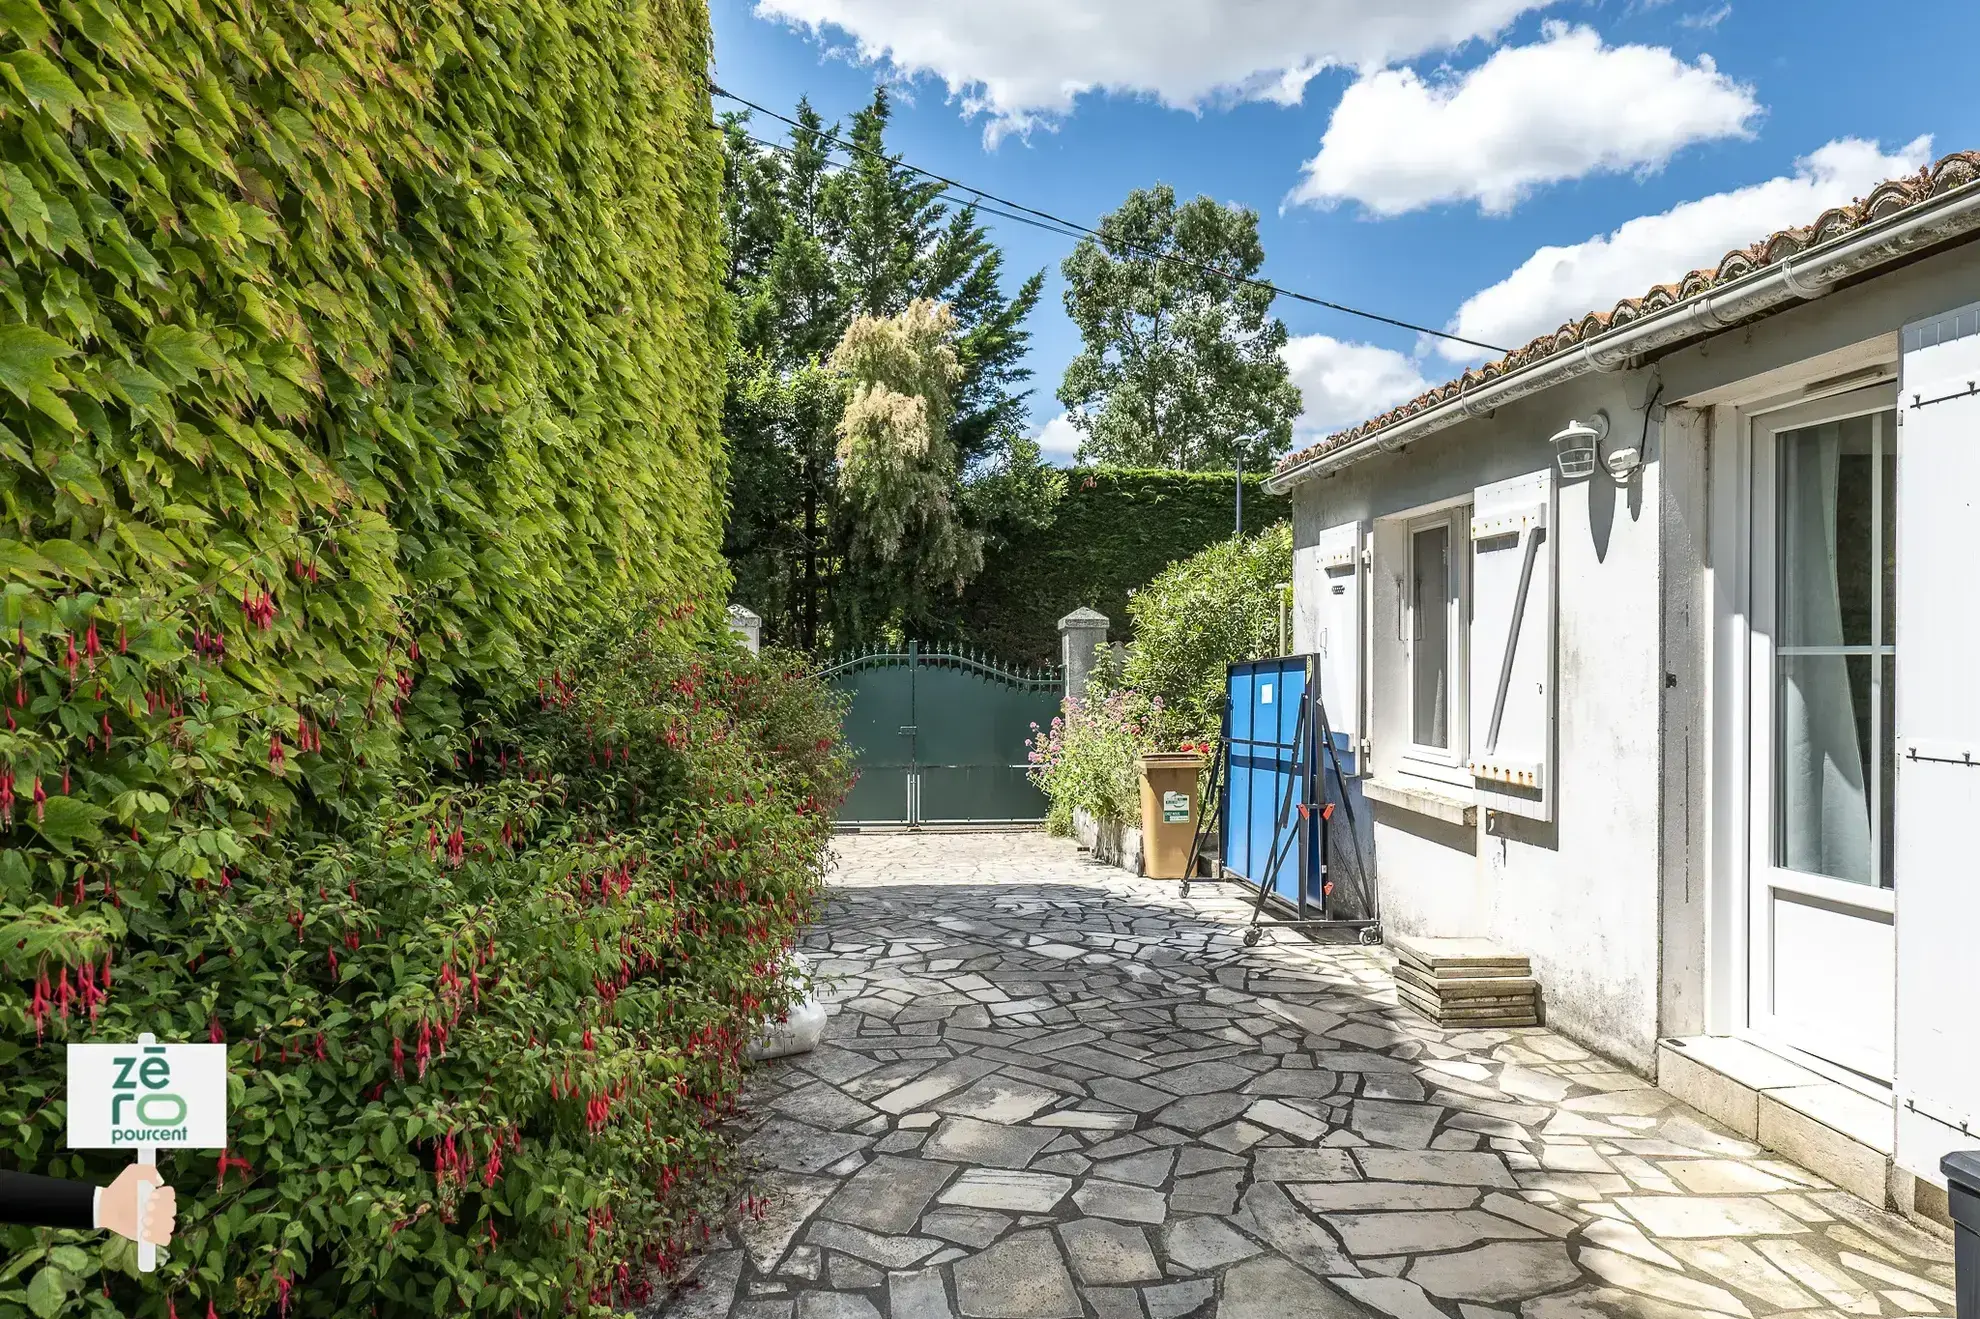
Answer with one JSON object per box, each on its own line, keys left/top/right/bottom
{"left": 1774, "top": 656, "right": 1877, "bottom": 883}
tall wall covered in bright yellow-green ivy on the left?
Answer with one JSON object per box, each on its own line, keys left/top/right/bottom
{"left": 0, "top": 0, "right": 727, "bottom": 720}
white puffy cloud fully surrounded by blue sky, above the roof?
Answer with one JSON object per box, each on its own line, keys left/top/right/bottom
{"left": 1289, "top": 22, "right": 1760, "bottom": 216}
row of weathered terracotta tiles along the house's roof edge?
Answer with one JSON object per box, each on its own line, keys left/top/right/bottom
{"left": 1275, "top": 151, "right": 1980, "bottom": 471}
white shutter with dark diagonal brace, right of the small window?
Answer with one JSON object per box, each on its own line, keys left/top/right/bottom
{"left": 1465, "top": 467, "right": 1556, "bottom": 820}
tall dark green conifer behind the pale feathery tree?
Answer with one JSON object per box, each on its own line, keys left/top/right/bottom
{"left": 723, "top": 91, "right": 1043, "bottom": 650}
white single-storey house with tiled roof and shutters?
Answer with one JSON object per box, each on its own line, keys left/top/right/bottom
{"left": 1267, "top": 152, "right": 1980, "bottom": 1216}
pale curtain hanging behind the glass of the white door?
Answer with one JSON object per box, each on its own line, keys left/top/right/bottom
{"left": 1776, "top": 424, "right": 1875, "bottom": 883}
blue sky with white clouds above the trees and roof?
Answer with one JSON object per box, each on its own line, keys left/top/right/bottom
{"left": 711, "top": 0, "right": 1980, "bottom": 461}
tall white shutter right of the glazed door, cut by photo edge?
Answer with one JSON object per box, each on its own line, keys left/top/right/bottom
{"left": 1893, "top": 305, "right": 1980, "bottom": 1184}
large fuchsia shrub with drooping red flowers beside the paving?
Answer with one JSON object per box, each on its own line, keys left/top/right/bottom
{"left": 0, "top": 609, "right": 849, "bottom": 1317}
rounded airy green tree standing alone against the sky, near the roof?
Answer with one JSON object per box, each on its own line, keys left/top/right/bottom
{"left": 1059, "top": 184, "right": 1301, "bottom": 469}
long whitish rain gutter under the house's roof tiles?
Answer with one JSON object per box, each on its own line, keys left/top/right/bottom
{"left": 1265, "top": 182, "right": 1980, "bottom": 495}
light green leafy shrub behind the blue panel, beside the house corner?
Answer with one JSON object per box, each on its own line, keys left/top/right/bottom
{"left": 1123, "top": 523, "right": 1293, "bottom": 745}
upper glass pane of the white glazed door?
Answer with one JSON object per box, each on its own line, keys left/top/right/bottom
{"left": 1776, "top": 416, "right": 1873, "bottom": 646}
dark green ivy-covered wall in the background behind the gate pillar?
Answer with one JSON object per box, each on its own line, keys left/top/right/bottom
{"left": 958, "top": 467, "right": 1291, "bottom": 663}
